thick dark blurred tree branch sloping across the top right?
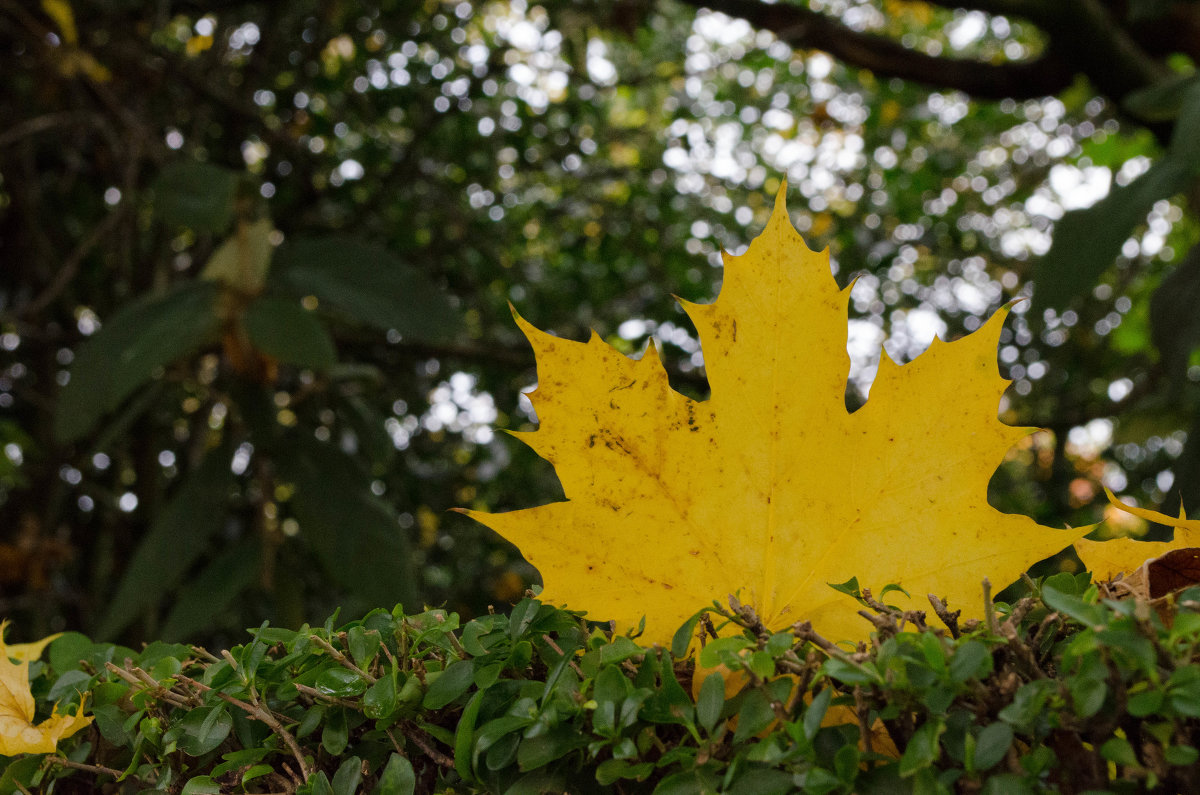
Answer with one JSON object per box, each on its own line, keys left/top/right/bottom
{"left": 683, "top": 0, "right": 1075, "bottom": 100}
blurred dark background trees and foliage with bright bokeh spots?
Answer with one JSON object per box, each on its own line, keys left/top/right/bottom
{"left": 0, "top": 0, "right": 1200, "bottom": 644}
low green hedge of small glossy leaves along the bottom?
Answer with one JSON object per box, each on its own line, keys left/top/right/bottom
{"left": 14, "top": 575, "right": 1200, "bottom": 795}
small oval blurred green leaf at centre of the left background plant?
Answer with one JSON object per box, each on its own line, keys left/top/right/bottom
{"left": 242, "top": 297, "right": 337, "bottom": 372}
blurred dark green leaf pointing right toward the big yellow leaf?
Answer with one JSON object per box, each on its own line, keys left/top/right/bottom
{"left": 272, "top": 237, "right": 460, "bottom": 341}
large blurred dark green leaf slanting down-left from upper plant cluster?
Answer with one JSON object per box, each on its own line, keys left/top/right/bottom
{"left": 54, "top": 282, "right": 221, "bottom": 442}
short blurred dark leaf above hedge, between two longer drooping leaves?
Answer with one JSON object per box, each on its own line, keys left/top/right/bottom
{"left": 158, "top": 538, "right": 262, "bottom": 640}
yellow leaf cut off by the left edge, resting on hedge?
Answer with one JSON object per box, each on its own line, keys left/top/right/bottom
{"left": 0, "top": 621, "right": 91, "bottom": 757}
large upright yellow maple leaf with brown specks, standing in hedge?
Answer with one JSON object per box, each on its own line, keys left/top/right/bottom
{"left": 464, "top": 189, "right": 1088, "bottom": 642}
